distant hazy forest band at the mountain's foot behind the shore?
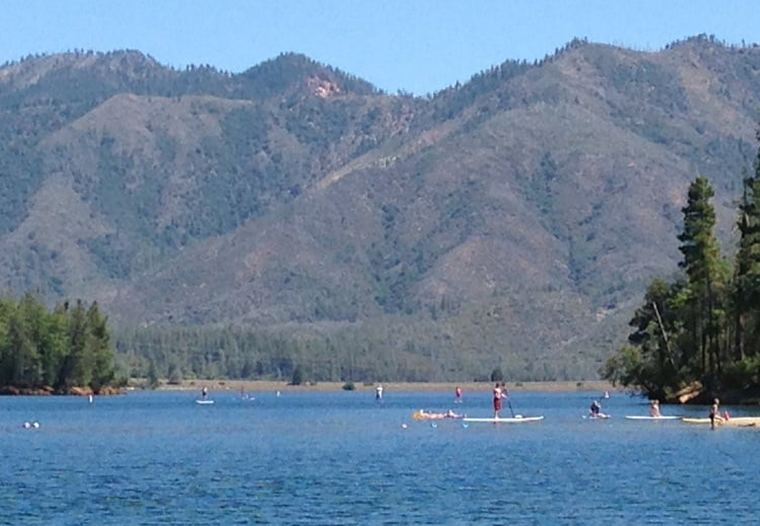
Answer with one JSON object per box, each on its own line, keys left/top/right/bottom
{"left": 114, "top": 317, "right": 598, "bottom": 383}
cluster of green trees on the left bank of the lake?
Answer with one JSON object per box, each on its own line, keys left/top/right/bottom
{"left": 0, "top": 294, "right": 115, "bottom": 393}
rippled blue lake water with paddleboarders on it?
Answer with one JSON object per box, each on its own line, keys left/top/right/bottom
{"left": 0, "top": 391, "right": 760, "bottom": 525}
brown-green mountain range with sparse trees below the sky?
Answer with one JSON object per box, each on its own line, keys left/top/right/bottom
{"left": 0, "top": 37, "right": 760, "bottom": 378}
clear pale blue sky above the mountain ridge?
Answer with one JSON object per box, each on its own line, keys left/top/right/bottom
{"left": 0, "top": 0, "right": 760, "bottom": 94}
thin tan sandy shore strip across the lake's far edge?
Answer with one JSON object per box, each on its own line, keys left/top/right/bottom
{"left": 159, "top": 380, "right": 619, "bottom": 393}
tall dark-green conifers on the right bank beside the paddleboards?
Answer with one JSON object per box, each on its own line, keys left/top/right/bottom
{"left": 602, "top": 132, "right": 760, "bottom": 401}
